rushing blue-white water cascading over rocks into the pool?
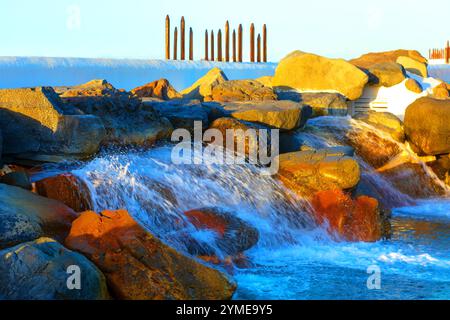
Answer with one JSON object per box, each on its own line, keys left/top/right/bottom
{"left": 60, "top": 119, "right": 450, "bottom": 299}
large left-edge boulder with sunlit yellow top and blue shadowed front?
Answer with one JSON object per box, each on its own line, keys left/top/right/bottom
{"left": 0, "top": 87, "right": 105, "bottom": 161}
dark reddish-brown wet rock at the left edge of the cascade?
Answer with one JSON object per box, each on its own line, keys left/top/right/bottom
{"left": 35, "top": 173, "right": 93, "bottom": 212}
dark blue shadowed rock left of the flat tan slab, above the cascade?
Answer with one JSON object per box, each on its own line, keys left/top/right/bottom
{"left": 143, "top": 99, "right": 209, "bottom": 132}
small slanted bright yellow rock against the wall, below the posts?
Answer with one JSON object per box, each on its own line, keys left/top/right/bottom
{"left": 181, "top": 68, "right": 228, "bottom": 100}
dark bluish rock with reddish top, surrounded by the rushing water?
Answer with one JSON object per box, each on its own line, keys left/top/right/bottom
{"left": 184, "top": 207, "right": 259, "bottom": 256}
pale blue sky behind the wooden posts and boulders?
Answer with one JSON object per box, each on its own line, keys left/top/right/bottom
{"left": 0, "top": 0, "right": 450, "bottom": 61}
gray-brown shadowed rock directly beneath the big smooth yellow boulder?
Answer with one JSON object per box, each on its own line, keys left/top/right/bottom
{"left": 277, "top": 91, "right": 349, "bottom": 118}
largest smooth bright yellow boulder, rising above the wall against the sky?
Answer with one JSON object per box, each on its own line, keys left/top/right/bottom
{"left": 273, "top": 51, "right": 368, "bottom": 100}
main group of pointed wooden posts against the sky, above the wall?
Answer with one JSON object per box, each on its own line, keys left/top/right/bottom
{"left": 165, "top": 15, "right": 267, "bottom": 63}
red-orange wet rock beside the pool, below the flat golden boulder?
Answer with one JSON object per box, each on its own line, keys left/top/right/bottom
{"left": 311, "top": 190, "right": 384, "bottom": 242}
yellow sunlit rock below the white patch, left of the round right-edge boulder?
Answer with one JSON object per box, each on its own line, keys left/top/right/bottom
{"left": 353, "top": 110, "right": 405, "bottom": 143}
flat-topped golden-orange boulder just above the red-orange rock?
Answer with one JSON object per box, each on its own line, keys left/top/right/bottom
{"left": 274, "top": 149, "right": 360, "bottom": 196}
